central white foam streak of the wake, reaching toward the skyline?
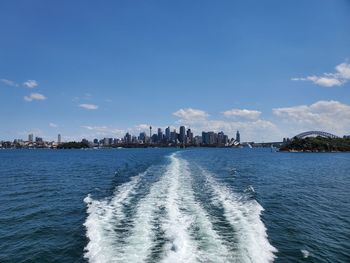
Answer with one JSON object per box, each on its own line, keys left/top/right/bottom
{"left": 162, "top": 156, "right": 229, "bottom": 262}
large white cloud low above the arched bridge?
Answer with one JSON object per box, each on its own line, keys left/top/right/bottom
{"left": 272, "top": 100, "right": 350, "bottom": 135}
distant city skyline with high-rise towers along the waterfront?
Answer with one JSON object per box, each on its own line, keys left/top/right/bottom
{"left": 0, "top": 126, "right": 247, "bottom": 149}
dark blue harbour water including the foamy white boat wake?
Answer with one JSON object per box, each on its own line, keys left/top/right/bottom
{"left": 0, "top": 148, "right": 350, "bottom": 263}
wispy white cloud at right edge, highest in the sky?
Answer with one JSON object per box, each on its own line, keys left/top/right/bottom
{"left": 292, "top": 63, "right": 350, "bottom": 87}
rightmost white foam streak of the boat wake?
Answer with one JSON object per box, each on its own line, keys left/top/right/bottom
{"left": 202, "top": 169, "right": 277, "bottom": 262}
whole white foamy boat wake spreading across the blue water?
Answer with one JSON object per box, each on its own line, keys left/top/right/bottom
{"left": 84, "top": 154, "right": 276, "bottom": 263}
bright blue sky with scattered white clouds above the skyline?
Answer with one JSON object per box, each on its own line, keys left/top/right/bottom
{"left": 0, "top": 0, "right": 350, "bottom": 141}
